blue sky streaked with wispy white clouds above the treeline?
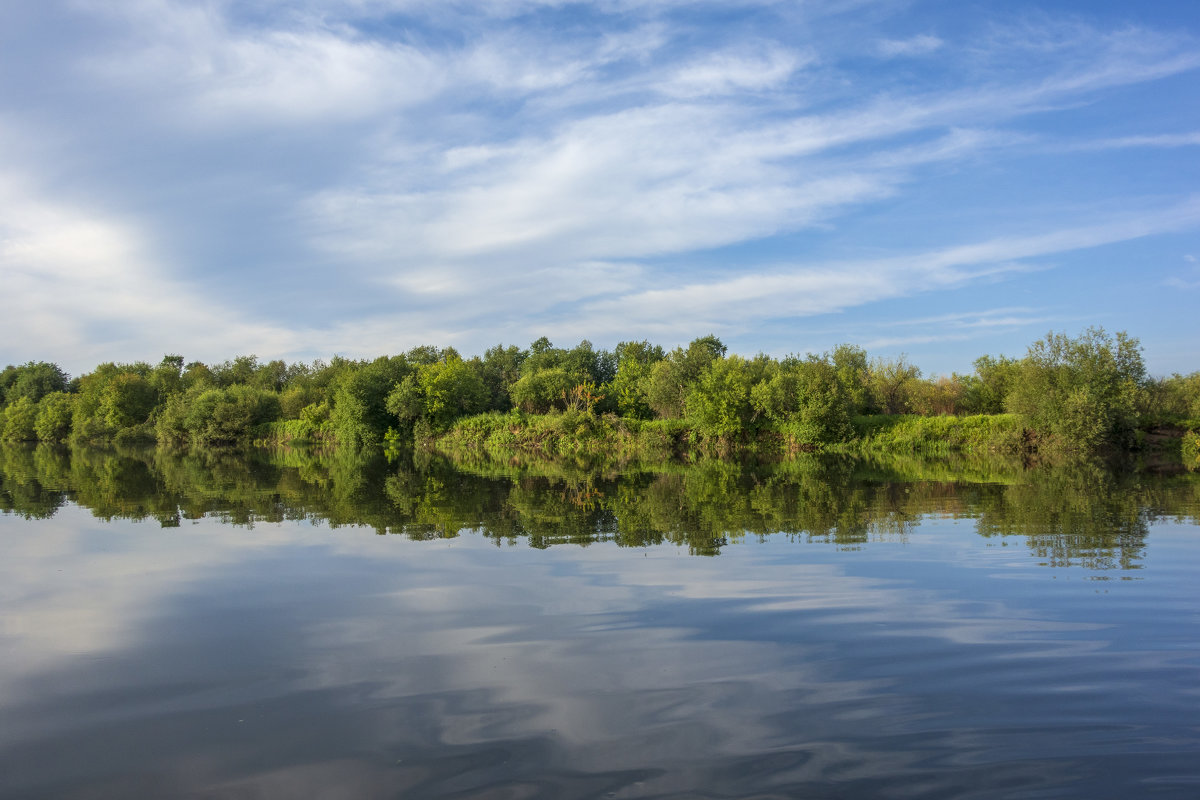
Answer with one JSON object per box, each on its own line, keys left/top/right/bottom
{"left": 0, "top": 0, "right": 1200, "bottom": 375}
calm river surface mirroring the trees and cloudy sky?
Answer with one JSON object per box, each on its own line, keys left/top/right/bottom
{"left": 0, "top": 449, "right": 1200, "bottom": 798}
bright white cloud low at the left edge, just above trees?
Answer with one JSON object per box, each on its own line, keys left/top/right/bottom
{"left": 0, "top": 172, "right": 304, "bottom": 369}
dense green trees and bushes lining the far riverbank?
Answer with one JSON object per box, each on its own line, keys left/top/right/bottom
{"left": 0, "top": 329, "right": 1200, "bottom": 461}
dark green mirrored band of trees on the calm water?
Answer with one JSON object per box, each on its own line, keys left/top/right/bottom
{"left": 0, "top": 445, "right": 1200, "bottom": 570}
